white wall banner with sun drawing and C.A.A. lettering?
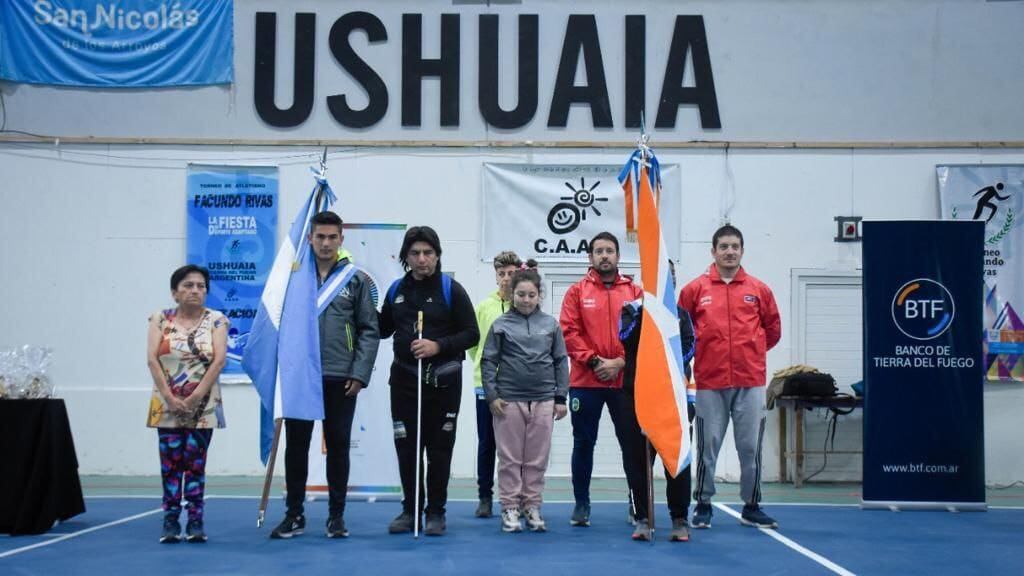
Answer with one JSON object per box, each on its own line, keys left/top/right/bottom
{"left": 480, "top": 164, "right": 681, "bottom": 264}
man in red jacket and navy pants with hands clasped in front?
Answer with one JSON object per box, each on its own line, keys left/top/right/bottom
{"left": 560, "top": 232, "right": 643, "bottom": 526}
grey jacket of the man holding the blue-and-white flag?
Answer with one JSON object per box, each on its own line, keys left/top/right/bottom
{"left": 319, "top": 258, "right": 380, "bottom": 387}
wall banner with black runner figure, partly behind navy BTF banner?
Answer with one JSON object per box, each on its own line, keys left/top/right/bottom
{"left": 937, "top": 164, "right": 1024, "bottom": 382}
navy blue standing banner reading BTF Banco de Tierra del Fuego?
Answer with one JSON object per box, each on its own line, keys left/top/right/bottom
{"left": 863, "top": 220, "right": 985, "bottom": 509}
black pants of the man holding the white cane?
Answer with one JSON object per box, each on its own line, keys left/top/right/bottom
{"left": 391, "top": 372, "right": 462, "bottom": 515}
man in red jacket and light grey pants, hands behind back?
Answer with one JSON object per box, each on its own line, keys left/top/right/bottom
{"left": 679, "top": 224, "right": 782, "bottom": 528}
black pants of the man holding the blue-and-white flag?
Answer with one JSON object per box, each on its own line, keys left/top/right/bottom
{"left": 285, "top": 378, "right": 356, "bottom": 517}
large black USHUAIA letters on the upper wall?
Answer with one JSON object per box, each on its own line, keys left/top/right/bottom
{"left": 253, "top": 11, "right": 722, "bottom": 130}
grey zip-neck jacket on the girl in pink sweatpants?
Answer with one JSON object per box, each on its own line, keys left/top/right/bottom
{"left": 480, "top": 307, "right": 569, "bottom": 404}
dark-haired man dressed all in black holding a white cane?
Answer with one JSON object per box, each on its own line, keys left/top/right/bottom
{"left": 380, "top": 227, "right": 480, "bottom": 536}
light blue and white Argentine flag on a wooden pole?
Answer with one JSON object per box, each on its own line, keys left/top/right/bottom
{"left": 242, "top": 174, "right": 335, "bottom": 464}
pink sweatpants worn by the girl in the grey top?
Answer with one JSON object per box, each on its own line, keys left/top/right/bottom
{"left": 494, "top": 400, "right": 555, "bottom": 509}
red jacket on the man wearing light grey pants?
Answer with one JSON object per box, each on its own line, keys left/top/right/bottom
{"left": 679, "top": 264, "right": 782, "bottom": 389}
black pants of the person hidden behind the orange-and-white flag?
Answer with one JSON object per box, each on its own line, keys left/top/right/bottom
{"left": 623, "top": 389, "right": 693, "bottom": 520}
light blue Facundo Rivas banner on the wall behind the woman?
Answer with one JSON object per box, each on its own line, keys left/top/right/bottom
{"left": 185, "top": 164, "right": 278, "bottom": 381}
